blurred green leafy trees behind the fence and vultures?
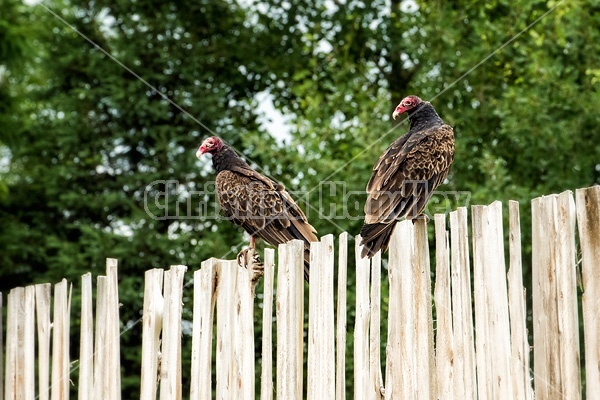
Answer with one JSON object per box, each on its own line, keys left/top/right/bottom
{"left": 0, "top": 0, "right": 600, "bottom": 398}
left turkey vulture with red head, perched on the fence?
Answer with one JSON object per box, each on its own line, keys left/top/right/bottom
{"left": 196, "top": 136, "right": 319, "bottom": 281}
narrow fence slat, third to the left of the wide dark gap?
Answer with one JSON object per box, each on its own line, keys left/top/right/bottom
{"left": 77, "top": 272, "right": 94, "bottom": 400}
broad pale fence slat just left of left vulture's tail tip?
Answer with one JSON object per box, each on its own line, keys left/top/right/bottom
{"left": 276, "top": 240, "right": 304, "bottom": 399}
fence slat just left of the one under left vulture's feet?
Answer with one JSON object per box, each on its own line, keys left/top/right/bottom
{"left": 216, "top": 260, "right": 239, "bottom": 400}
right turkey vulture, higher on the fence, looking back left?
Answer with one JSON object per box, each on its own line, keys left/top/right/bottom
{"left": 360, "top": 96, "right": 454, "bottom": 258}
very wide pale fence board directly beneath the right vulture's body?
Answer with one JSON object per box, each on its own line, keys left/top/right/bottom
{"left": 385, "top": 220, "right": 436, "bottom": 400}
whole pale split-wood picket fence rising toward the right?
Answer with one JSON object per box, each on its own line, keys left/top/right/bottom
{"left": 0, "top": 186, "right": 600, "bottom": 400}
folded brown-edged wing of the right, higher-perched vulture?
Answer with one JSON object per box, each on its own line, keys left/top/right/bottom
{"left": 365, "top": 125, "right": 454, "bottom": 224}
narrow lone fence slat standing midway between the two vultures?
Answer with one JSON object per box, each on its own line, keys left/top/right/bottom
{"left": 336, "top": 232, "right": 348, "bottom": 400}
